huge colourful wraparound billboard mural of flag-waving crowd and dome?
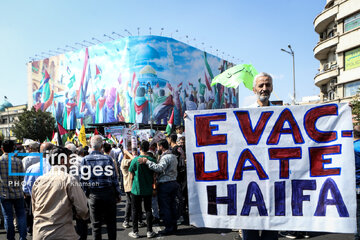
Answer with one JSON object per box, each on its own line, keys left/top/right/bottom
{"left": 28, "top": 36, "right": 238, "bottom": 129}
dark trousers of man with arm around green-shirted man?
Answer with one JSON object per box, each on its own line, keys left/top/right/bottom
{"left": 158, "top": 181, "right": 179, "bottom": 233}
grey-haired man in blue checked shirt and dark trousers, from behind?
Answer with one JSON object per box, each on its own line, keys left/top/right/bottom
{"left": 81, "top": 135, "right": 121, "bottom": 240}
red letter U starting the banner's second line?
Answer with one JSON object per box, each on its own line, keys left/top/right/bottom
{"left": 194, "top": 152, "right": 229, "bottom": 181}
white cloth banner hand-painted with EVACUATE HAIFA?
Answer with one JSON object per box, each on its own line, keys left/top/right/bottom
{"left": 185, "top": 104, "right": 356, "bottom": 233}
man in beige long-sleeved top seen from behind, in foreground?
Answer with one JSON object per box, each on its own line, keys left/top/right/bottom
{"left": 32, "top": 147, "right": 89, "bottom": 240}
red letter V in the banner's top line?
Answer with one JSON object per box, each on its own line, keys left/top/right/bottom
{"left": 234, "top": 111, "right": 273, "bottom": 145}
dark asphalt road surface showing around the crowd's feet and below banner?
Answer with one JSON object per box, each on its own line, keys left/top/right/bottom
{"left": 0, "top": 198, "right": 354, "bottom": 240}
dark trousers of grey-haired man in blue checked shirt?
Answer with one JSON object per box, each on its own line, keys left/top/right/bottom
{"left": 88, "top": 187, "right": 116, "bottom": 240}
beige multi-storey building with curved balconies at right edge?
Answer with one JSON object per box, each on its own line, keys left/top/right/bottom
{"left": 314, "top": 0, "right": 360, "bottom": 102}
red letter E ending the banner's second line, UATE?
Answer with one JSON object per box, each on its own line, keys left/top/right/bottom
{"left": 309, "top": 145, "right": 341, "bottom": 177}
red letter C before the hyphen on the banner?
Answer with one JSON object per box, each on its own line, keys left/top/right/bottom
{"left": 304, "top": 104, "right": 338, "bottom": 143}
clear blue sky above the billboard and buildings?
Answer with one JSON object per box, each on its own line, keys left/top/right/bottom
{"left": 0, "top": 0, "right": 325, "bottom": 105}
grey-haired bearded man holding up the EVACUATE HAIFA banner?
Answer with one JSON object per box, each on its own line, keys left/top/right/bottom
{"left": 242, "top": 72, "right": 278, "bottom": 240}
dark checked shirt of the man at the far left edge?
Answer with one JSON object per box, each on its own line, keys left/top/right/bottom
{"left": 0, "top": 153, "right": 24, "bottom": 199}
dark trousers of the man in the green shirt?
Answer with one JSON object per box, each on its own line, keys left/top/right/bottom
{"left": 131, "top": 194, "right": 152, "bottom": 232}
